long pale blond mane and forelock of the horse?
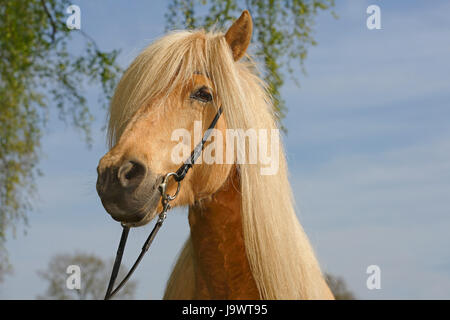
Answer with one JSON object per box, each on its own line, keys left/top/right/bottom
{"left": 108, "top": 30, "right": 324, "bottom": 299}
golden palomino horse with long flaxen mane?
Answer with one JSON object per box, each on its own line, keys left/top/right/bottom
{"left": 97, "top": 11, "right": 333, "bottom": 299}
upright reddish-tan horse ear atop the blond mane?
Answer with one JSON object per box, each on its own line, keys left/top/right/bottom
{"left": 225, "top": 10, "right": 253, "bottom": 61}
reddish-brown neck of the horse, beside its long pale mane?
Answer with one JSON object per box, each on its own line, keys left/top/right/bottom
{"left": 189, "top": 169, "right": 260, "bottom": 299}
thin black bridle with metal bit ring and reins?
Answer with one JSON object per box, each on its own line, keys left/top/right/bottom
{"left": 105, "top": 107, "right": 222, "bottom": 300}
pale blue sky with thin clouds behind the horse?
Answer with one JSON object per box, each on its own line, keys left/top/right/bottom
{"left": 0, "top": 0, "right": 450, "bottom": 299}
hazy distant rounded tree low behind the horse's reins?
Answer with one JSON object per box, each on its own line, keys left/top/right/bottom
{"left": 37, "top": 253, "right": 136, "bottom": 300}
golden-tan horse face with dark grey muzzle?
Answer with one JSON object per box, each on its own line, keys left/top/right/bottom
{"left": 97, "top": 73, "right": 230, "bottom": 226}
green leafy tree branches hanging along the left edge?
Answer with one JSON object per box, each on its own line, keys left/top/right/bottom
{"left": 0, "top": 0, "right": 121, "bottom": 280}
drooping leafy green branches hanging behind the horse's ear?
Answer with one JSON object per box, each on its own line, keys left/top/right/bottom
{"left": 166, "top": 0, "right": 334, "bottom": 128}
